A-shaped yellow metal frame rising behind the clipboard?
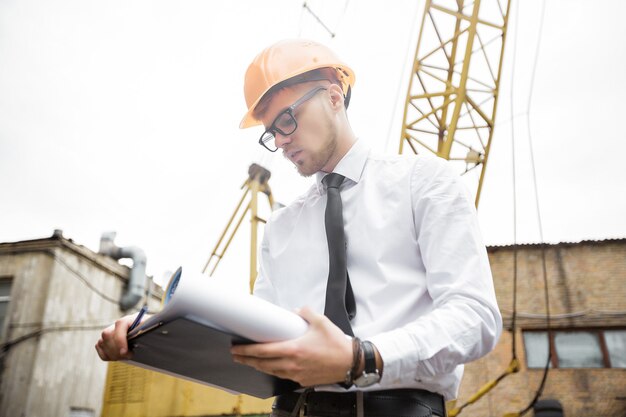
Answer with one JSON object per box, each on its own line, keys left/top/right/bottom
{"left": 202, "top": 164, "right": 274, "bottom": 292}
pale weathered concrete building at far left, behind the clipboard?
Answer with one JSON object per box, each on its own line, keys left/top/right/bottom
{"left": 0, "top": 231, "right": 160, "bottom": 417}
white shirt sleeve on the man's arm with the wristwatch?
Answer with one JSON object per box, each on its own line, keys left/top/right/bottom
{"left": 370, "top": 158, "right": 502, "bottom": 386}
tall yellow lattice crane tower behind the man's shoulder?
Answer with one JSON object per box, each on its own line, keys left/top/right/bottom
{"left": 399, "top": 0, "right": 511, "bottom": 206}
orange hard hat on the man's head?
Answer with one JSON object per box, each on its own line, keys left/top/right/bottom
{"left": 239, "top": 39, "right": 354, "bottom": 129}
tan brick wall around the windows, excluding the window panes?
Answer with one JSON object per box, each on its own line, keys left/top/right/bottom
{"left": 456, "top": 239, "right": 626, "bottom": 417}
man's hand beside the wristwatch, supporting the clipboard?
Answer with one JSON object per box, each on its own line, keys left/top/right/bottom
{"left": 231, "top": 308, "right": 353, "bottom": 387}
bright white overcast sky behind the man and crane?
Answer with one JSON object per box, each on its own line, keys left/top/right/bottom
{"left": 0, "top": 0, "right": 626, "bottom": 286}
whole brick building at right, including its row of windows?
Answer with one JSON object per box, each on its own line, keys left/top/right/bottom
{"left": 457, "top": 239, "right": 626, "bottom": 417}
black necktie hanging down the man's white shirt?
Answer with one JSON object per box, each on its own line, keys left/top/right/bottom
{"left": 322, "top": 173, "right": 356, "bottom": 336}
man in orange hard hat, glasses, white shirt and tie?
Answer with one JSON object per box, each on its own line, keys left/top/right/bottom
{"left": 96, "top": 40, "right": 502, "bottom": 417}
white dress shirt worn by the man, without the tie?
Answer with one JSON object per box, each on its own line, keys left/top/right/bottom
{"left": 254, "top": 141, "right": 502, "bottom": 400}
